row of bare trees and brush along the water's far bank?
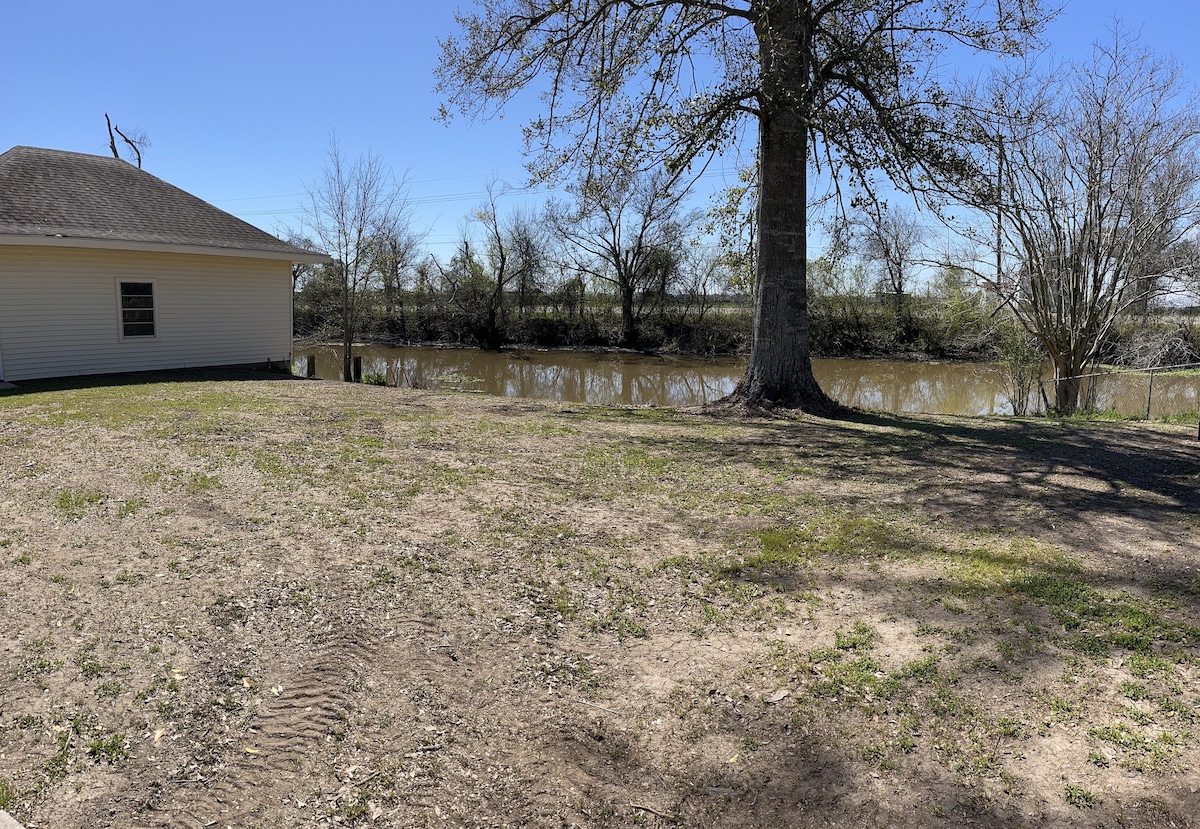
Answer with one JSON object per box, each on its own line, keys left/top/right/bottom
{"left": 295, "top": 146, "right": 1200, "bottom": 369}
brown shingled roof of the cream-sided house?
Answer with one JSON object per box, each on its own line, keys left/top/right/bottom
{"left": 0, "top": 146, "right": 329, "bottom": 262}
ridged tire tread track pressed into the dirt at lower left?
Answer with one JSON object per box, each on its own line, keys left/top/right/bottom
{"left": 151, "top": 633, "right": 380, "bottom": 829}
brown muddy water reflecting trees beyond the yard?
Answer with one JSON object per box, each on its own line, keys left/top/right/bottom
{"left": 293, "top": 343, "right": 1200, "bottom": 417}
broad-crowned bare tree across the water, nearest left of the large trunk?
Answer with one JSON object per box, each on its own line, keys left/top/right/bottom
{"left": 547, "top": 168, "right": 698, "bottom": 347}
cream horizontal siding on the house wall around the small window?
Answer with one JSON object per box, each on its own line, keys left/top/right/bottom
{"left": 0, "top": 246, "right": 292, "bottom": 380}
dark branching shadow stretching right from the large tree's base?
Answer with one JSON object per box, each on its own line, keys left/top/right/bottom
{"left": 690, "top": 410, "right": 1200, "bottom": 556}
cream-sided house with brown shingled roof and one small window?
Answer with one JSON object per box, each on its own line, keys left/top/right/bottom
{"left": 0, "top": 146, "right": 330, "bottom": 382}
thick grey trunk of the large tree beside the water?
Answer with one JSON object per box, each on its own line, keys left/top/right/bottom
{"left": 733, "top": 4, "right": 834, "bottom": 410}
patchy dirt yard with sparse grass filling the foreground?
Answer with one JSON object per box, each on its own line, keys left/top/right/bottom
{"left": 0, "top": 376, "right": 1200, "bottom": 829}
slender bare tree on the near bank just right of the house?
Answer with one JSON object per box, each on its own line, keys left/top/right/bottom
{"left": 305, "top": 137, "right": 410, "bottom": 380}
